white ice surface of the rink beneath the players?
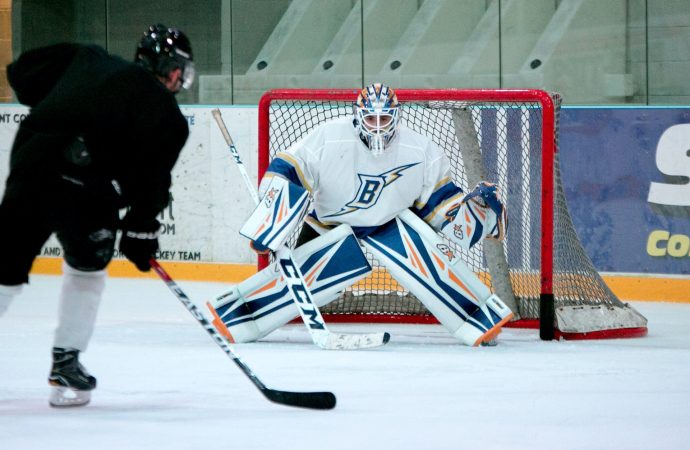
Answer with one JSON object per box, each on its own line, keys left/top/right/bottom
{"left": 0, "top": 276, "right": 690, "bottom": 450}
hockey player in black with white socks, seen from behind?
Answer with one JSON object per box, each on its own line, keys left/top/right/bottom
{"left": 0, "top": 25, "right": 194, "bottom": 406}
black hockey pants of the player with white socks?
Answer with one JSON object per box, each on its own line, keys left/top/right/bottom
{"left": 0, "top": 174, "right": 119, "bottom": 286}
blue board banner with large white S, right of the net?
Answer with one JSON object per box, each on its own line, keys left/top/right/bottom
{"left": 556, "top": 107, "right": 690, "bottom": 274}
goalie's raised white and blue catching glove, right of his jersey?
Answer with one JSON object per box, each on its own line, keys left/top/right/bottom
{"left": 441, "top": 181, "right": 508, "bottom": 250}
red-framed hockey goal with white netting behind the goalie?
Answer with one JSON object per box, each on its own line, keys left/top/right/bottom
{"left": 259, "top": 89, "right": 647, "bottom": 339}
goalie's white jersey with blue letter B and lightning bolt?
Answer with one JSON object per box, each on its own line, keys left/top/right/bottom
{"left": 262, "top": 118, "right": 463, "bottom": 235}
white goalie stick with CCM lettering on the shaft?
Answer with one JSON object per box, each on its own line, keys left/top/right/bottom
{"left": 211, "top": 108, "right": 390, "bottom": 350}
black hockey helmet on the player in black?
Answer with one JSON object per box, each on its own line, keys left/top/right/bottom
{"left": 134, "top": 24, "right": 194, "bottom": 89}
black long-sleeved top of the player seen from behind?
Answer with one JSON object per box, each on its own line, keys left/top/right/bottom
{"left": 6, "top": 44, "right": 189, "bottom": 220}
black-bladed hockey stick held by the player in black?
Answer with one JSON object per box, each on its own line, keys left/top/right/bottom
{"left": 149, "top": 258, "right": 335, "bottom": 409}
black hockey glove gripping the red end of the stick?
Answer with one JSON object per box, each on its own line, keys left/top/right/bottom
{"left": 120, "top": 215, "right": 160, "bottom": 272}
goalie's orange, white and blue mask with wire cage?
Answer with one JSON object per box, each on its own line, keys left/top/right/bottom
{"left": 353, "top": 83, "right": 400, "bottom": 156}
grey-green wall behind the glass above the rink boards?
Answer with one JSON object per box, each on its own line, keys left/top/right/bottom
{"left": 11, "top": 0, "right": 690, "bottom": 104}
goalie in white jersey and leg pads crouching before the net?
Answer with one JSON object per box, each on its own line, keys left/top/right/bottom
{"left": 208, "top": 83, "right": 513, "bottom": 346}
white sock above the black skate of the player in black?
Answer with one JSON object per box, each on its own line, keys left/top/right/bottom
{"left": 53, "top": 263, "right": 106, "bottom": 352}
